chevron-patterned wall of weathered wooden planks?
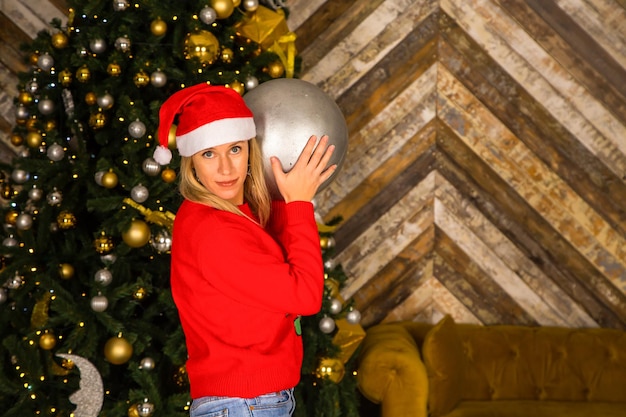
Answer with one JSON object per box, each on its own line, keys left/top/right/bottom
{"left": 0, "top": 0, "right": 626, "bottom": 328}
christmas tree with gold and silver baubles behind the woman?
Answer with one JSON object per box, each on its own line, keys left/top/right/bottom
{"left": 0, "top": 0, "right": 362, "bottom": 417}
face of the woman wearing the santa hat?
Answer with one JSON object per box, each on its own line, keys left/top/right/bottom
{"left": 191, "top": 140, "right": 249, "bottom": 205}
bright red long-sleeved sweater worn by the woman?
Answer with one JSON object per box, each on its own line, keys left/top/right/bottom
{"left": 171, "top": 200, "right": 324, "bottom": 398}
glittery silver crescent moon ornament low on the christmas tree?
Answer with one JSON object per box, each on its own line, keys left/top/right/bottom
{"left": 56, "top": 353, "right": 104, "bottom": 417}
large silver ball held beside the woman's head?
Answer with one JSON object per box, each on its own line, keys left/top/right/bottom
{"left": 243, "top": 78, "right": 348, "bottom": 202}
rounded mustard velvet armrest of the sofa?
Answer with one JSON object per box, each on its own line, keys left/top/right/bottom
{"left": 357, "top": 323, "right": 428, "bottom": 417}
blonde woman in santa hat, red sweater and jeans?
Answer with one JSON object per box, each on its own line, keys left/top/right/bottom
{"left": 155, "top": 84, "right": 336, "bottom": 417}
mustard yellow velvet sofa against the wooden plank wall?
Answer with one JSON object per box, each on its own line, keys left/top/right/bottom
{"left": 357, "top": 316, "right": 626, "bottom": 417}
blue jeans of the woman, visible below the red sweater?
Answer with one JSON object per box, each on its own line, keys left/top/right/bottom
{"left": 189, "top": 388, "right": 296, "bottom": 417}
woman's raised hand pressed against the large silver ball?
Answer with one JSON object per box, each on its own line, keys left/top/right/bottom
{"left": 270, "top": 135, "right": 337, "bottom": 203}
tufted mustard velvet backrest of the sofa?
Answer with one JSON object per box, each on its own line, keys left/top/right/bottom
{"left": 422, "top": 316, "right": 626, "bottom": 415}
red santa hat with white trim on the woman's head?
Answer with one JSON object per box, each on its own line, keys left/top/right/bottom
{"left": 154, "top": 83, "right": 256, "bottom": 165}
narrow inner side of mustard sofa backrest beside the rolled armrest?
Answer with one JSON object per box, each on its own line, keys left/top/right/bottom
{"left": 422, "top": 315, "right": 464, "bottom": 417}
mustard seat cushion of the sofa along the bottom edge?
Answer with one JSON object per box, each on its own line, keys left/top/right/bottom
{"left": 444, "top": 400, "right": 626, "bottom": 417}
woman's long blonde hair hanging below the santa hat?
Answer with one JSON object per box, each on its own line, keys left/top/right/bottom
{"left": 179, "top": 138, "right": 272, "bottom": 227}
